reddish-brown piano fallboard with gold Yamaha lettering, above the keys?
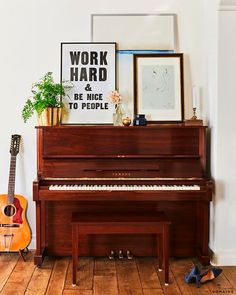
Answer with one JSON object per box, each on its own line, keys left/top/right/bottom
{"left": 41, "top": 155, "right": 202, "bottom": 179}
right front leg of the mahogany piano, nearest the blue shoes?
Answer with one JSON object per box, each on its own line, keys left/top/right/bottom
{"left": 197, "top": 202, "right": 210, "bottom": 265}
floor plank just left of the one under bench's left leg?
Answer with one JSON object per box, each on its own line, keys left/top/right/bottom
{"left": 46, "top": 257, "right": 69, "bottom": 295}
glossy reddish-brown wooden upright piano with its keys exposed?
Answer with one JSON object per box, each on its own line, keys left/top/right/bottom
{"left": 33, "top": 124, "right": 212, "bottom": 265}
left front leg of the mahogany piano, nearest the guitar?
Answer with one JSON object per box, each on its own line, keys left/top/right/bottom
{"left": 34, "top": 201, "right": 45, "bottom": 267}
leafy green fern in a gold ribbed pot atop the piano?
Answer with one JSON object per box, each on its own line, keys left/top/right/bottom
{"left": 22, "top": 72, "right": 72, "bottom": 125}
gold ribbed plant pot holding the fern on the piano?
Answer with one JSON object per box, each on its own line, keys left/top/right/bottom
{"left": 38, "top": 108, "right": 61, "bottom": 126}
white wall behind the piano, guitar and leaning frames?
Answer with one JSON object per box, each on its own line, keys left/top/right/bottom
{"left": 0, "top": 0, "right": 235, "bottom": 266}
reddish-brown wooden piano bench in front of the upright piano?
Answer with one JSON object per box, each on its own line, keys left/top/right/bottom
{"left": 71, "top": 212, "right": 170, "bottom": 286}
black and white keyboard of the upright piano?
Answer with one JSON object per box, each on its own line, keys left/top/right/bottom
{"left": 49, "top": 185, "right": 200, "bottom": 191}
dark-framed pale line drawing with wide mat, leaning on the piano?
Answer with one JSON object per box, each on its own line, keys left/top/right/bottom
{"left": 134, "top": 53, "right": 184, "bottom": 123}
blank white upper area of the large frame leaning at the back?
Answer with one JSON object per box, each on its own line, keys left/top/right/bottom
{"left": 91, "top": 13, "right": 176, "bottom": 50}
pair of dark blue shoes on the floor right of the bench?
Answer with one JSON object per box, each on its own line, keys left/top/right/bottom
{"left": 184, "top": 266, "right": 222, "bottom": 288}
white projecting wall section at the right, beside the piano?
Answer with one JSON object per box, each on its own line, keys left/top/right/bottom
{"left": 209, "top": 0, "right": 236, "bottom": 265}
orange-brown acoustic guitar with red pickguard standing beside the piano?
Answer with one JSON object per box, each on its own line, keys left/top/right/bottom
{"left": 0, "top": 134, "right": 31, "bottom": 253}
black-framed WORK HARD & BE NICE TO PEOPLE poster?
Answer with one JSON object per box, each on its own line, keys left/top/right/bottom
{"left": 61, "top": 42, "right": 116, "bottom": 124}
